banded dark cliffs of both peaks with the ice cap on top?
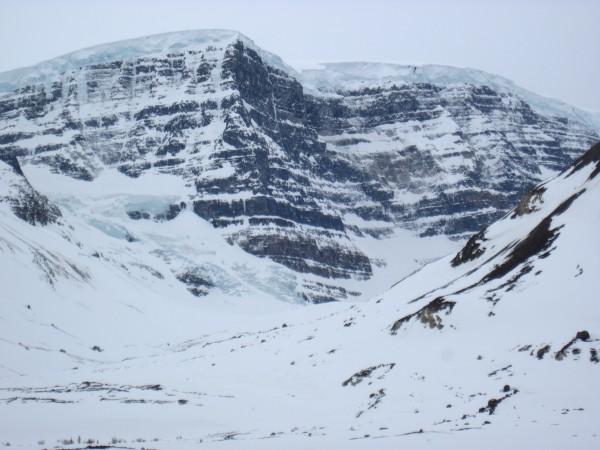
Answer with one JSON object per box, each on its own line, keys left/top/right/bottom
{"left": 0, "top": 31, "right": 598, "bottom": 301}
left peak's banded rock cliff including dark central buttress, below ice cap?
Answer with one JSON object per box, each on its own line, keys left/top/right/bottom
{"left": 0, "top": 35, "right": 372, "bottom": 292}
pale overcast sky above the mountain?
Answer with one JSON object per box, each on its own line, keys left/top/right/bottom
{"left": 0, "top": 0, "right": 600, "bottom": 111}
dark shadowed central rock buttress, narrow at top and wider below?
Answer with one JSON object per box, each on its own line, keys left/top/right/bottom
{"left": 194, "top": 41, "right": 371, "bottom": 278}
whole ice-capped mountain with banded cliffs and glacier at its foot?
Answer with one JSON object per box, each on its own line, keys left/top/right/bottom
{"left": 0, "top": 30, "right": 600, "bottom": 302}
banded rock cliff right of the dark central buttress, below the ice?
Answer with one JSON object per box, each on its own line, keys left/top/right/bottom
{"left": 309, "top": 81, "right": 598, "bottom": 235}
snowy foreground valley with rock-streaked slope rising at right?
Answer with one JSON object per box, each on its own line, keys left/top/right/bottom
{"left": 0, "top": 138, "right": 600, "bottom": 450}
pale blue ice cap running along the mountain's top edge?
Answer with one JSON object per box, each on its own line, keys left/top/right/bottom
{"left": 0, "top": 29, "right": 600, "bottom": 131}
